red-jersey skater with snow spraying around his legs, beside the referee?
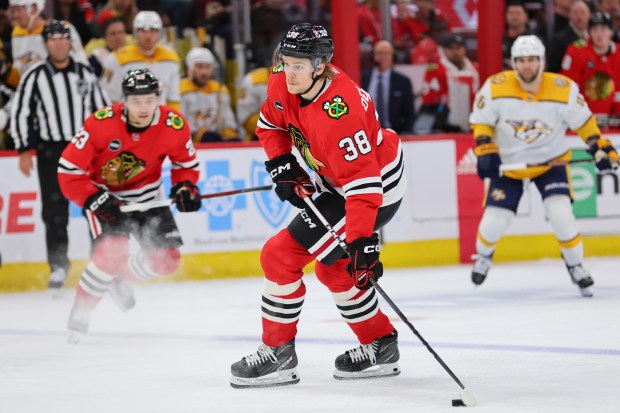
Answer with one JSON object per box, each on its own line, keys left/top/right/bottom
{"left": 58, "top": 69, "right": 201, "bottom": 341}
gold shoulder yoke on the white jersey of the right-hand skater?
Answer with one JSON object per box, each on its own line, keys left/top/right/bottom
{"left": 490, "top": 70, "right": 571, "bottom": 103}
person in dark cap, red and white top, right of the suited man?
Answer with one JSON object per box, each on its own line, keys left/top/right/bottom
{"left": 420, "top": 34, "right": 480, "bottom": 132}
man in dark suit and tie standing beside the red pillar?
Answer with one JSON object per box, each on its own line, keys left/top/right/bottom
{"left": 362, "top": 40, "right": 414, "bottom": 134}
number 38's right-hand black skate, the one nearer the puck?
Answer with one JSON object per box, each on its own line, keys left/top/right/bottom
{"left": 334, "top": 330, "right": 400, "bottom": 380}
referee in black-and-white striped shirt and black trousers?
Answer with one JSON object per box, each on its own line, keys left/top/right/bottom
{"left": 11, "top": 20, "right": 109, "bottom": 291}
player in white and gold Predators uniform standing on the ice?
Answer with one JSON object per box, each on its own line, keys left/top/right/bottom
{"left": 470, "top": 36, "right": 618, "bottom": 297}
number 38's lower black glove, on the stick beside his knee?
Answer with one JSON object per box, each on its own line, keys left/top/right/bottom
{"left": 347, "top": 234, "right": 383, "bottom": 290}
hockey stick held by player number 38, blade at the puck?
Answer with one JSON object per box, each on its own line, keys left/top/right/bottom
{"left": 298, "top": 193, "right": 478, "bottom": 407}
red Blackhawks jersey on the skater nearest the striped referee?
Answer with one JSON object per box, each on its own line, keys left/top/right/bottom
{"left": 58, "top": 103, "right": 199, "bottom": 206}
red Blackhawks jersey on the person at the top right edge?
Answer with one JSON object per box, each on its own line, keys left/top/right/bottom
{"left": 561, "top": 39, "right": 620, "bottom": 115}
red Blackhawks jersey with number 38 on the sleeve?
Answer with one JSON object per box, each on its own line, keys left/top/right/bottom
{"left": 256, "top": 65, "right": 406, "bottom": 242}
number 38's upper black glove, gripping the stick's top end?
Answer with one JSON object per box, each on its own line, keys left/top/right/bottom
{"left": 265, "top": 153, "right": 316, "bottom": 208}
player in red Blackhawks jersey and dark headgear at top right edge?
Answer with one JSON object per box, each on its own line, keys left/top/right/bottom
{"left": 561, "top": 12, "right": 620, "bottom": 120}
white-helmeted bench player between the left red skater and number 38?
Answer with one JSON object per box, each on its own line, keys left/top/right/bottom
{"left": 181, "top": 47, "right": 239, "bottom": 142}
